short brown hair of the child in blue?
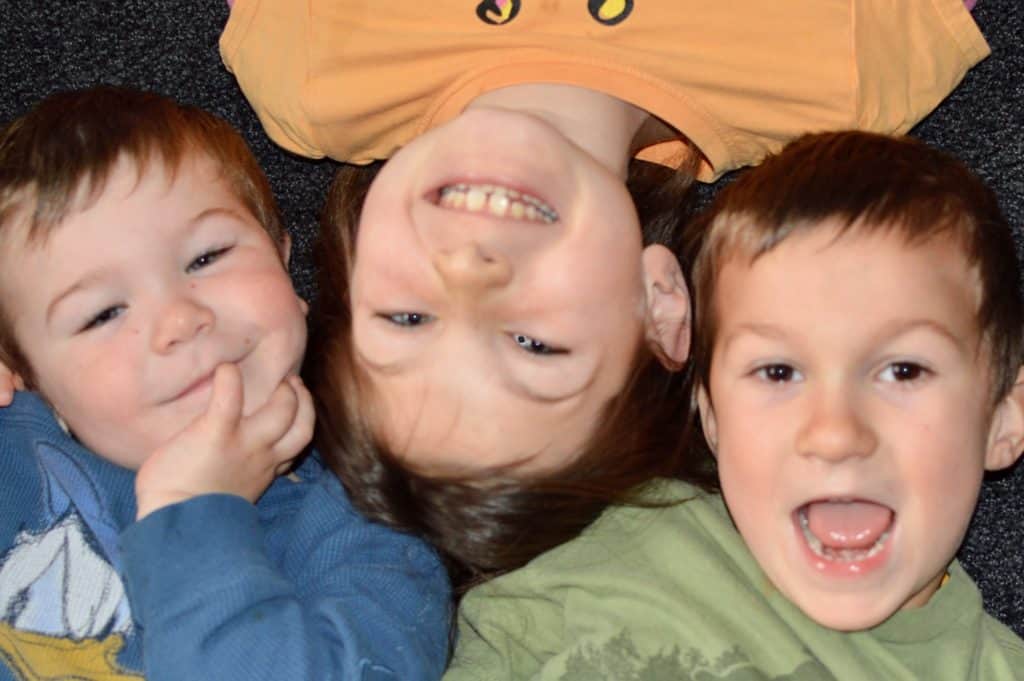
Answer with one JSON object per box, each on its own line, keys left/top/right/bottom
{"left": 0, "top": 86, "right": 285, "bottom": 386}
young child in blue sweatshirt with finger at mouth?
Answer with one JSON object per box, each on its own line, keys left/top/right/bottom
{"left": 0, "top": 87, "right": 449, "bottom": 681}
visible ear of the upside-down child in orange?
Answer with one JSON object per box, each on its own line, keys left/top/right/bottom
{"left": 642, "top": 244, "right": 690, "bottom": 371}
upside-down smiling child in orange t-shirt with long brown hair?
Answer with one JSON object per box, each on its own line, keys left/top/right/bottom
{"left": 221, "top": 0, "right": 988, "bottom": 578}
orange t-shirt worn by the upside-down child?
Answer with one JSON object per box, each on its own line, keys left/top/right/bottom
{"left": 220, "top": 0, "right": 989, "bottom": 180}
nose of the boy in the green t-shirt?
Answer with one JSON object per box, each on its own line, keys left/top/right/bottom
{"left": 797, "top": 387, "right": 879, "bottom": 462}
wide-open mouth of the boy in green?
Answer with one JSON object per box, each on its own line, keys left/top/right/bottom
{"left": 796, "top": 499, "right": 896, "bottom": 563}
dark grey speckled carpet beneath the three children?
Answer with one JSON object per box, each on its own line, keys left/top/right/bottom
{"left": 0, "top": 0, "right": 1024, "bottom": 635}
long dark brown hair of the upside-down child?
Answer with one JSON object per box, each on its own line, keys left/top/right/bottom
{"left": 306, "top": 156, "right": 714, "bottom": 588}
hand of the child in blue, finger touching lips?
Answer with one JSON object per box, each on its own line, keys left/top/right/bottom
{"left": 135, "top": 365, "right": 314, "bottom": 519}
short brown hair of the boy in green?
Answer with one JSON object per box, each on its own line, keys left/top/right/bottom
{"left": 686, "top": 131, "right": 1024, "bottom": 409}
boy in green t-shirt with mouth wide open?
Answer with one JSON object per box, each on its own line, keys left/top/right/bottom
{"left": 445, "top": 132, "right": 1024, "bottom": 681}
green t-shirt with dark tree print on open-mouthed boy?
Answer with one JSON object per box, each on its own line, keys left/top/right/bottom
{"left": 444, "top": 482, "right": 1024, "bottom": 681}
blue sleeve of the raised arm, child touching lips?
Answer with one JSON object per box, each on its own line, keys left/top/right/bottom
{"left": 122, "top": 466, "right": 451, "bottom": 681}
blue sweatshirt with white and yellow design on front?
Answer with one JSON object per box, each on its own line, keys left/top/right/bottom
{"left": 0, "top": 392, "right": 450, "bottom": 681}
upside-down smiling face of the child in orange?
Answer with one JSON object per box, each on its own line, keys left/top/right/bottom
{"left": 351, "top": 109, "right": 659, "bottom": 473}
